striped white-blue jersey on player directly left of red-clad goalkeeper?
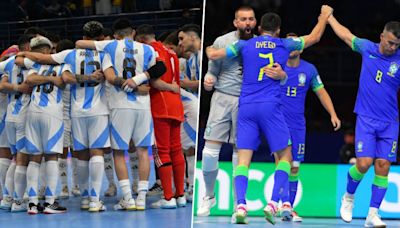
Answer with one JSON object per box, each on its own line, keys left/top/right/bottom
{"left": 95, "top": 38, "right": 156, "bottom": 110}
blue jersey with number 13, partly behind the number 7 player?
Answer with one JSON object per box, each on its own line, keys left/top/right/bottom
{"left": 281, "top": 60, "right": 324, "bottom": 129}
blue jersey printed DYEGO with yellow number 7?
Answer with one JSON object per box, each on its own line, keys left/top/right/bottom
{"left": 226, "top": 35, "right": 304, "bottom": 104}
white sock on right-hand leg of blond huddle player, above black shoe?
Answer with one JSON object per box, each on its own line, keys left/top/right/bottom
{"left": 45, "top": 161, "right": 59, "bottom": 204}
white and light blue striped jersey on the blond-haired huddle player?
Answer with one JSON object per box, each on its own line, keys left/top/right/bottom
{"left": 28, "top": 64, "right": 68, "bottom": 120}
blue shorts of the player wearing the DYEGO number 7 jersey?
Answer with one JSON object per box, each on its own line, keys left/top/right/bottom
{"left": 236, "top": 102, "right": 291, "bottom": 152}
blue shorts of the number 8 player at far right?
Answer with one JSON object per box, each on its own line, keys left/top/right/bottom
{"left": 355, "top": 115, "right": 399, "bottom": 162}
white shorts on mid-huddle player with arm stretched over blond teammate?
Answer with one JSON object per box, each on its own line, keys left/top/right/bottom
{"left": 71, "top": 115, "right": 110, "bottom": 151}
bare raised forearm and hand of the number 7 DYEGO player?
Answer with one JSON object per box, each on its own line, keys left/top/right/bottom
{"left": 301, "top": 5, "right": 333, "bottom": 48}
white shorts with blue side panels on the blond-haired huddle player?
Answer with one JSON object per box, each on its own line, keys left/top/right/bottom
{"left": 25, "top": 112, "right": 64, "bottom": 154}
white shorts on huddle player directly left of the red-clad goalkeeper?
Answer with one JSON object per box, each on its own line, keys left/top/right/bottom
{"left": 110, "top": 109, "right": 154, "bottom": 150}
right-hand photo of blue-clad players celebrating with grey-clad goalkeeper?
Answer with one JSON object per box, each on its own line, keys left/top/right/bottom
{"left": 193, "top": 0, "right": 400, "bottom": 228}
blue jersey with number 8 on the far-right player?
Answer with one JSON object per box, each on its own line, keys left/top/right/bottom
{"left": 352, "top": 37, "right": 400, "bottom": 122}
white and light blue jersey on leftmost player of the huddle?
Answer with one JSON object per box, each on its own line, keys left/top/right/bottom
{"left": 0, "top": 56, "right": 38, "bottom": 122}
